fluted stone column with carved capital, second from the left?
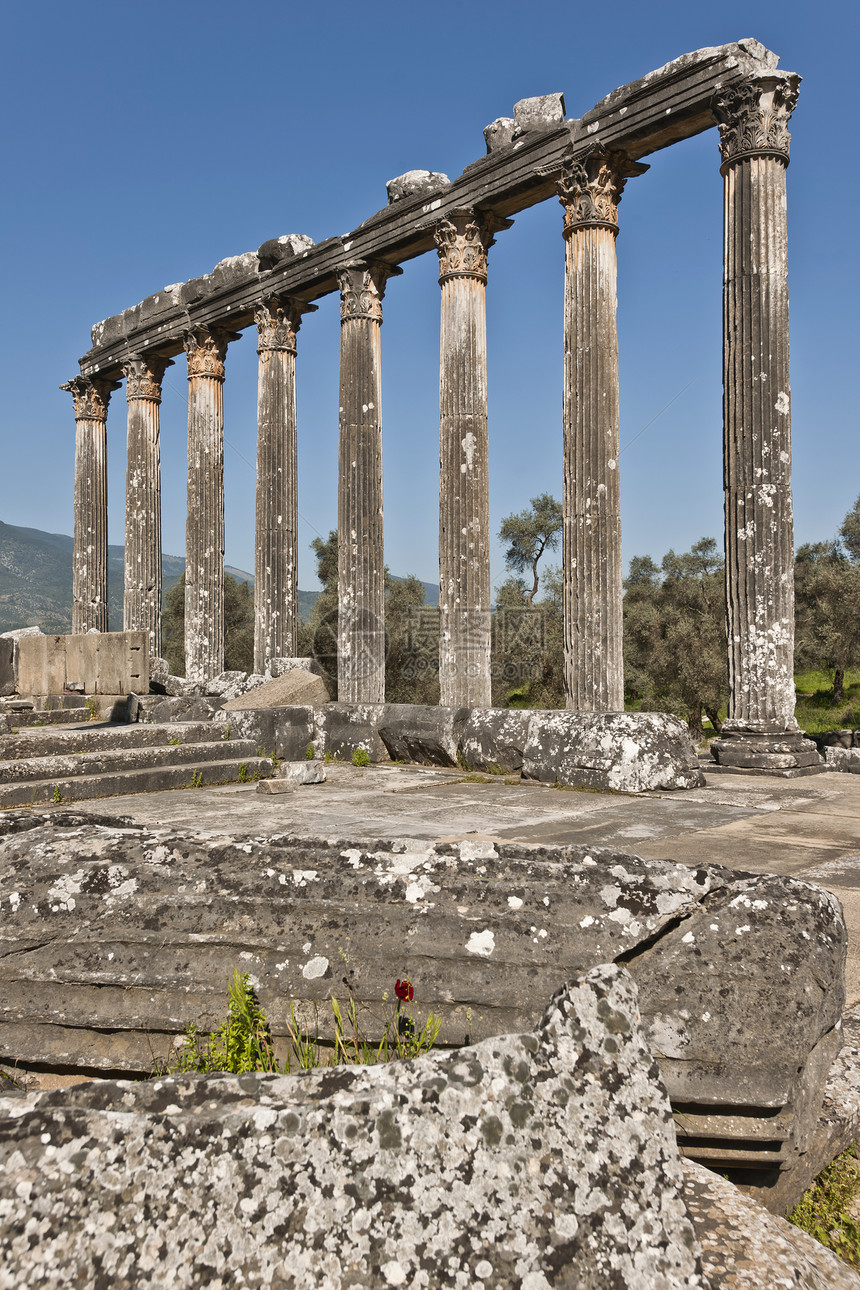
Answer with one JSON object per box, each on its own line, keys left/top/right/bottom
{"left": 122, "top": 355, "right": 173, "bottom": 658}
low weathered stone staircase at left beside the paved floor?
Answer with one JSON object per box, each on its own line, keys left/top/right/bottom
{"left": 0, "top": 710, "right": 273, "bottom": 808}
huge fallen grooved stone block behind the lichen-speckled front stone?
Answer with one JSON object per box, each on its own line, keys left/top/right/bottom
{"left": 0, "top": 811, "right": 846, "bottom": 1186}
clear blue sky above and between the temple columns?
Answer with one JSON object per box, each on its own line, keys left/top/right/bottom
{"left": 0, "top": 0, "right": 860, "bottom": 588}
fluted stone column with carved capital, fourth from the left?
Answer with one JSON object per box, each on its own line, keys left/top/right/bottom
{"left": 254, "top": 295, "right": 316, "bottom": 672}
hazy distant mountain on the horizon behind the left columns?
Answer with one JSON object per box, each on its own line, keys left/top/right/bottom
{"left": 0, "top": 520, "right": 438, "bottom": 633}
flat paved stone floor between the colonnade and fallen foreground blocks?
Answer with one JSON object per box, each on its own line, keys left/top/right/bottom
{"left": 62, "top": 765, "right": 860, "bottom": 1005}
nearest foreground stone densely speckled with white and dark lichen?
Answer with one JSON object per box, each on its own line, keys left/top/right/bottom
{"left": 0, "top": 966, "right": 707, "bottom": 1290}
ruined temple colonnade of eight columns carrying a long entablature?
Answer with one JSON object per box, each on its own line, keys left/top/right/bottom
{"left": 63, "top": 40, "right": 817, "bottom": 769}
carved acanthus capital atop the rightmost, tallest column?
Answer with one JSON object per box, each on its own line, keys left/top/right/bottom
{"left": 710, "top": 71, "right": 801, "bottom": 172}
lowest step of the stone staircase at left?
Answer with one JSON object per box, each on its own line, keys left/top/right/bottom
{"left": 0, "top": 757, "right": 273, "bottom": 808}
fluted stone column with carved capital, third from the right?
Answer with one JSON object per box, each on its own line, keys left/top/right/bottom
{"left": 436, "top": 210, "right": 512, "bottom": 708}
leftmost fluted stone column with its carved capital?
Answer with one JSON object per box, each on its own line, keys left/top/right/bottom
{"left": 59, "top": 377, "right": 120, "bottom": 633}
